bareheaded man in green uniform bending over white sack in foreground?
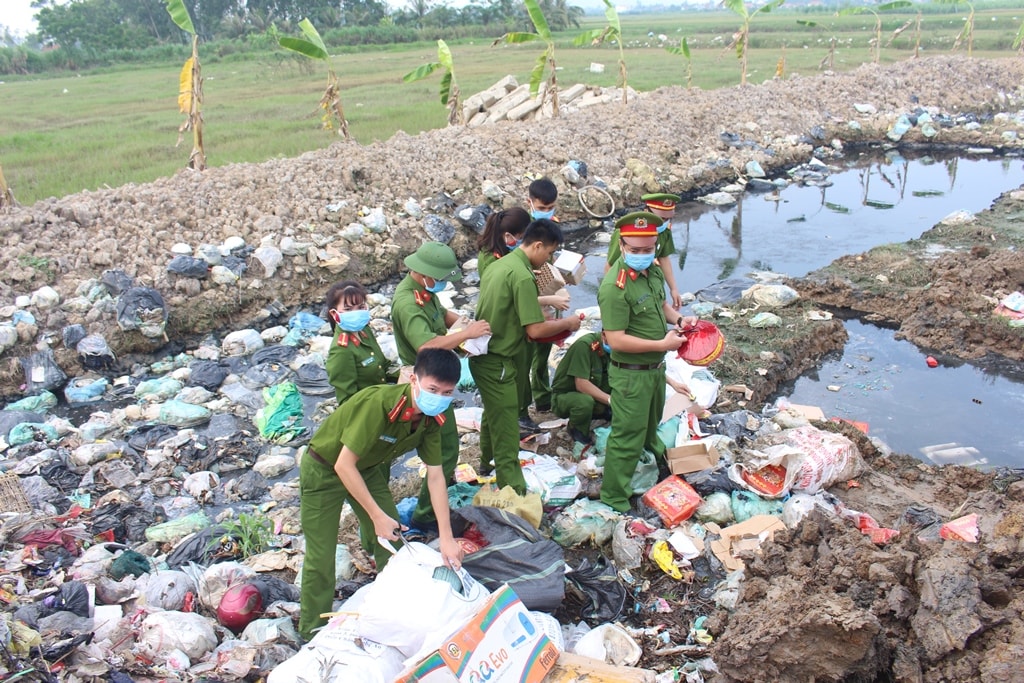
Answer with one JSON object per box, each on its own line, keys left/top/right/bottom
{"left": 299, "top": 348, "right": 462, "bottom": 640}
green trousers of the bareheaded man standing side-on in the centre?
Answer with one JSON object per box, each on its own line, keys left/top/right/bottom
{"left": 469, "top": 353, "right": 526, "bottom": 495}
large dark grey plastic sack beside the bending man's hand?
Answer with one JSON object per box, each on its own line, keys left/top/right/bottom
{"left": 452, "top": 505, "right": 565, "bottom": 611}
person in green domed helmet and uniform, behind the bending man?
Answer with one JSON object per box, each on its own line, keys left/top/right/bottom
{"left": 391, "top": 242, "right": 490, "bottom": 530}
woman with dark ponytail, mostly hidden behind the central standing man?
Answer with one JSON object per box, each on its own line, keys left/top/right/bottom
{"left": 476, "top": 208, "right": 569, "bottom": 432}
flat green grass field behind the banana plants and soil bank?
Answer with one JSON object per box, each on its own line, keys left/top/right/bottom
{"left": 0, "top": 9, "right": 1024, "bottom": 204}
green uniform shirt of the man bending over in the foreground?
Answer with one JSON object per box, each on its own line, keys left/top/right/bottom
{"left": 309, "top": 384, "right": 444, "bottom": 471}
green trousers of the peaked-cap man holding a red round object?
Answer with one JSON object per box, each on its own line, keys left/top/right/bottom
{"left": 601, "top": 365, "right": 665, "bottom": 512}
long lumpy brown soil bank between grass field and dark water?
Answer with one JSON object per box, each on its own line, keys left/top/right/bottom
{"left": 0, "top": 56, "right": 1024, "bottom": 393}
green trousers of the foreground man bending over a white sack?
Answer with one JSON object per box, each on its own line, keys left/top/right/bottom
{"left": 299, "top": 454, "right": 398, "bottom": 640}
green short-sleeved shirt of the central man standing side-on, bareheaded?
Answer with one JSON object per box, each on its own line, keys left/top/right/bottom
{"left": 476, "top": 249, "right": 544, "bottom": 359}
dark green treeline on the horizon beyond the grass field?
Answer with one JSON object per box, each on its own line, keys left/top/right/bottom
{"left": 0, "top": 0, "right": 584, "bottom": 74}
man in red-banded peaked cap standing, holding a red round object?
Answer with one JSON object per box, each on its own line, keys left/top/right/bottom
{"left": 597, "top": 211, "right": 695, "bottom": 512}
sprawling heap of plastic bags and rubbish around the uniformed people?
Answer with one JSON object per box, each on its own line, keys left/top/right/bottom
{"left": 0, "top": 264, "right": 995, "bottom": 681}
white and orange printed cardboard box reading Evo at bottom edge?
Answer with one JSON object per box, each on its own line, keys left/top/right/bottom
{"left": 395, "top": 586, "right": 558, "bottom": 683}
